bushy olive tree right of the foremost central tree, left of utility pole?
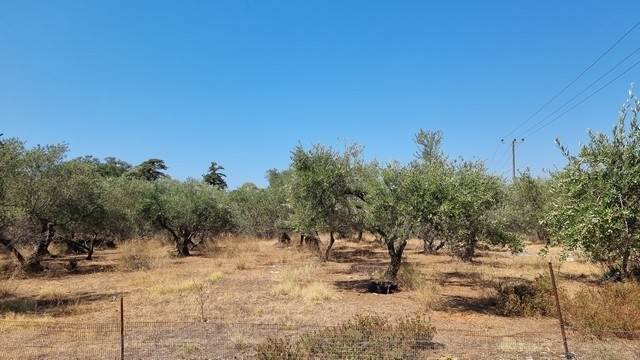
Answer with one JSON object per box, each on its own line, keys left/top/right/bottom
{"left": 444, "top": 161, "right": 522, "bottom": 261}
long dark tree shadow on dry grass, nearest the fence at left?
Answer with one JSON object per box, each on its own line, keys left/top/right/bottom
{"left": 0, "top": 293, "right": 121, "bottom": 314}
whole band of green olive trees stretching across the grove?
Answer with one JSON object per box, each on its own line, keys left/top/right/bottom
{"left": 0, "top": 92, "right": 640, "bottom": 281}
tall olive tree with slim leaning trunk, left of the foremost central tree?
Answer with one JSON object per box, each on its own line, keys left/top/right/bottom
{"left": 289, "top": 145, "right": 363, "bottom": 260}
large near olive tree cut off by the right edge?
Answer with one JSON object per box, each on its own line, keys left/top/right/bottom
{"left": 546, "top": 96, "right": 640, "bottom": 278}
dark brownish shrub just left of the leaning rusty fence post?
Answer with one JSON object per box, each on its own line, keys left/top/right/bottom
{"left": 495, "top": 275, "right": 564, "bottom": 316}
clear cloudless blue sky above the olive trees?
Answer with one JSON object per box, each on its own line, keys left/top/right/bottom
{"left": 0, "top": 0, "right": 640, "bottom": 187}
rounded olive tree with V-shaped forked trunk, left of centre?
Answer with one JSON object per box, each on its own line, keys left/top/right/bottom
{"left": 142, "top": 179, "right": 232, "bottom": 256}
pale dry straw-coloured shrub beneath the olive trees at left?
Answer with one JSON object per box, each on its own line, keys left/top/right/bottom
{"left": 117, "top": 240, "right": 169, "bottom": 271}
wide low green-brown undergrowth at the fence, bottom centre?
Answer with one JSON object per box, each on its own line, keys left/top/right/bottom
{"left": 256, "top": 315, "right": 436, "bottom": 360}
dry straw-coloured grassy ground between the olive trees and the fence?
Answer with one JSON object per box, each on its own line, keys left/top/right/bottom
{"left": 0, "top": 237, "right": 637, "bottom": 358}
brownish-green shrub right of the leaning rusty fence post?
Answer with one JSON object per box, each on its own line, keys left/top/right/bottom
{"left": 565, "top": 282, "right": 640, "bottom": 339}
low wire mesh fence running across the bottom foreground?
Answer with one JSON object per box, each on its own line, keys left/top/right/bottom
{"left": 0, "top": 321, "right": 640, "bottom": 360}
